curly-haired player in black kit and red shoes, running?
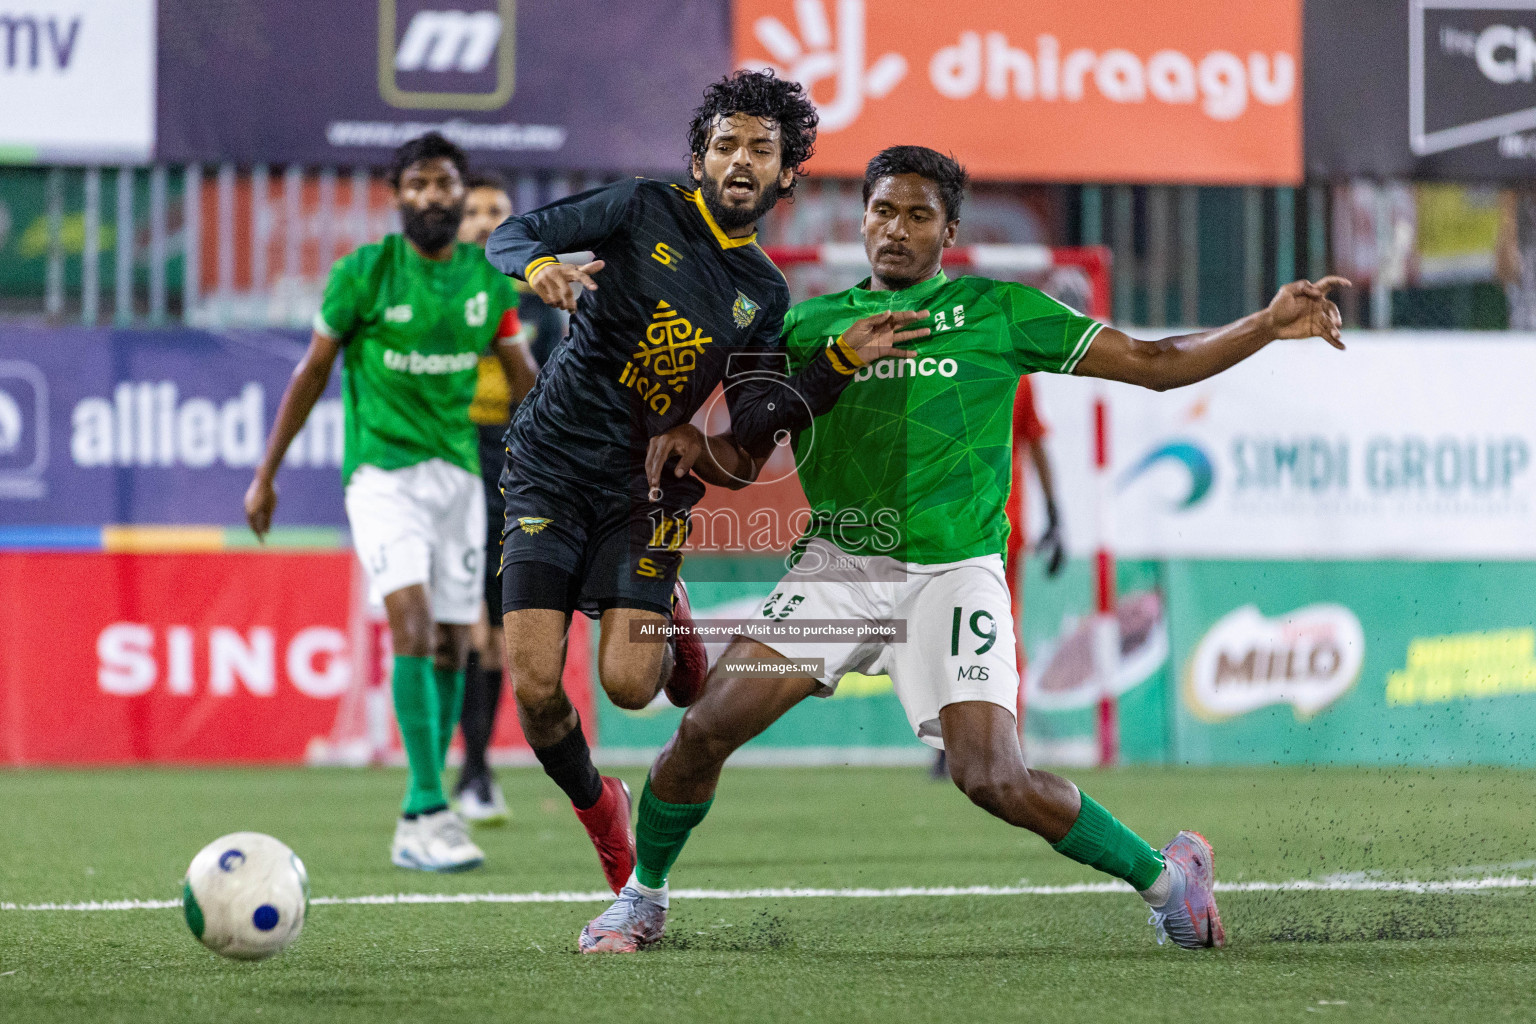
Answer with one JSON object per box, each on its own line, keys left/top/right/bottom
{"left": 485, "top": 72, "right": 928, "bottom": 892}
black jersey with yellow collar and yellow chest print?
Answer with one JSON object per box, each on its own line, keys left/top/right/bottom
{"left": 485, "top": 178, "right": 856, "bottom": 504}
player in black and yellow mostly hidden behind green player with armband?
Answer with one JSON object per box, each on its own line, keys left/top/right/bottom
{"left": 453, "top": 170, "right": 565, "bottom": 824}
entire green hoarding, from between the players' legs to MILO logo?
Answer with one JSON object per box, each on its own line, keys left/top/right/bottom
{"left": 599, "top": 560, "right": 1536, "bottom": 765}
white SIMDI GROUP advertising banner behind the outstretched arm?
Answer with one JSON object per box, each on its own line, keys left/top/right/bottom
{"left": 1035, "top": 332, "right": 1536, "bottom": 559}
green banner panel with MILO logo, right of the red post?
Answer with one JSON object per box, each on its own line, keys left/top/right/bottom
{"left": 1163, "top": 562, "right": 1536, "bottom": 765}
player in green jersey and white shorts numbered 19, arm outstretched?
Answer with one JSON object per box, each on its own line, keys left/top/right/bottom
{"left": 579, "top": 146, "right": 1347, "bottom": 952}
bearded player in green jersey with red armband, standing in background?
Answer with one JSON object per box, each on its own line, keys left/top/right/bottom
{"left": 246, "top": 132, "right": 535, "bottom": 870}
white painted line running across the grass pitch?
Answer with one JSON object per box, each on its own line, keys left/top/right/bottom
{"left": 0, "top": 875, "right": 1536, "bottom": 910}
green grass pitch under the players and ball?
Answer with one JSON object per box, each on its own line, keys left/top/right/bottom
{"left": 0, "top": 768, "right": 1536, "bottom": 1024}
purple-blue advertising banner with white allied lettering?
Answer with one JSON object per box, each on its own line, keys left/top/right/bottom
{"left": 0, "top": 327, "right": 346, "bottom": 527}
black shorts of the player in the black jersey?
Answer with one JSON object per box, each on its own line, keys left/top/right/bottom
{"left": 499, "top": 473, "right": 690, "bottom": 619}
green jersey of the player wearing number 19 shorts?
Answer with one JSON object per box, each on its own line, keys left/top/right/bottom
{"left": 785, "top": 272, "right": 1103, "bottom": 565}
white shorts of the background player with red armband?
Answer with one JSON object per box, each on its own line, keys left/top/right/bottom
{"left": 347, "top": 459, "right": 485, "bottom": 625}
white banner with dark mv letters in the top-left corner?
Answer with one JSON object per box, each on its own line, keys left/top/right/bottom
{"left": 0, "top": 0, "right": 155, "bottom": 163}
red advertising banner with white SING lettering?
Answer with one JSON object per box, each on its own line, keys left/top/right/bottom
{"left": 0, "top": 551, "right": 353, "bottom": 765}
